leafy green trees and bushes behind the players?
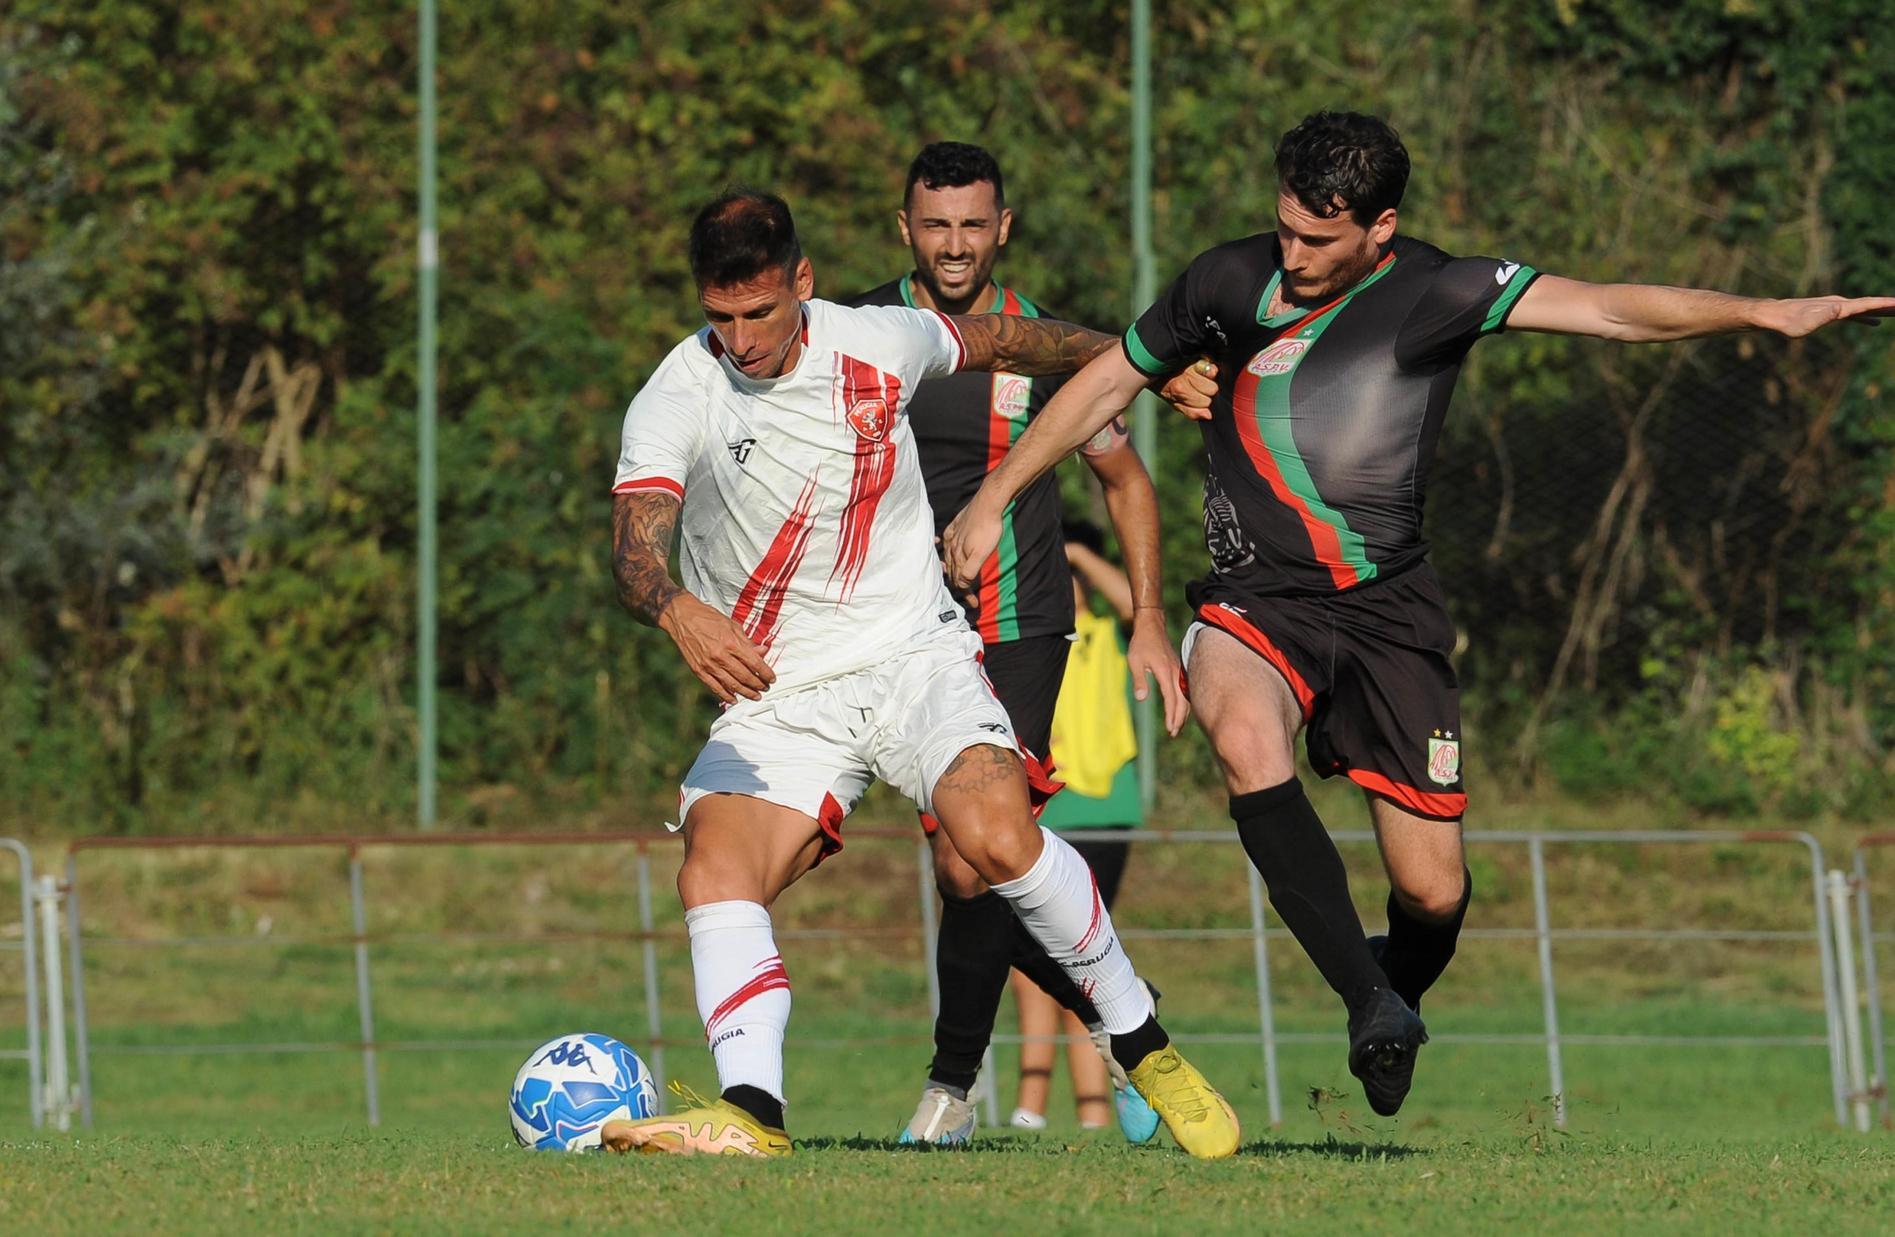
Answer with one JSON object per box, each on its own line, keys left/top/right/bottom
{"left": 0, "top": 0, "right": 1895, "bottom": 834}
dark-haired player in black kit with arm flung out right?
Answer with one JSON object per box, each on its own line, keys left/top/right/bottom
{"left": 944, "top": 112, "right": 1895, "bottom": 1114}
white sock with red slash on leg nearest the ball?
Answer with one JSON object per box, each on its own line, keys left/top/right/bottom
{"left": 684, "top": 902, "right": 790, "bottom": 1101}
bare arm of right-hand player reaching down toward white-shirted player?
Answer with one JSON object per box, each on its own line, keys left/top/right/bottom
{"left": 942, "top": 346, "right": 1146, "bottom": 589}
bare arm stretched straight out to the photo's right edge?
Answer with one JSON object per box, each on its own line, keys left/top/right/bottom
{"left": 1507, "top": 275, "right": 1895, "bottom": 343}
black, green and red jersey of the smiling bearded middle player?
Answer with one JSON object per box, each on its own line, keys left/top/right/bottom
{"left": 843, "top": 275, "right": 1073, "bottom": 644}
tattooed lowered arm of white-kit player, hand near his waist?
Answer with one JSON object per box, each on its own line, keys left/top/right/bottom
{"left": 612, "top": 491, "right": 777, "bottom": 705}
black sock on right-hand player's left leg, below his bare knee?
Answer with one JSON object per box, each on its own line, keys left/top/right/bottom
{"left": 1230, "top": 777, "right": 1389, "bottom": 1010}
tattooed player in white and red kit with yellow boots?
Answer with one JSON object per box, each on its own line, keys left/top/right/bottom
{"left": 605, "top": 191, "right": 1237, "bottom": 1157}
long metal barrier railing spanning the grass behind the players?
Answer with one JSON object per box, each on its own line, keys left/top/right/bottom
{"left": 55, "top": 830, "right": 1848, "bottom": 1125}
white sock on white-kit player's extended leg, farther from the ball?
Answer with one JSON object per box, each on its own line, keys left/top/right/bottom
{"left": 993, "top": 828, "right": 1152, "bottom": 1034}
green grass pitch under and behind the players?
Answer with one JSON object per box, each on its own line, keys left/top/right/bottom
{"left": 0, "top": 810, "right": 1895, "bottom": 1237}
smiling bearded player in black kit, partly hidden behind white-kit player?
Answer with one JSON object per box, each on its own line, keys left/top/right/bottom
{"left": 845, "top": 142, "right": 1213, "bottom": 1142}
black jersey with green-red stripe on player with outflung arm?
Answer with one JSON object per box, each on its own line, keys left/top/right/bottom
{"left": 1124, "top": 233, "right": 1537, "bottom": 597}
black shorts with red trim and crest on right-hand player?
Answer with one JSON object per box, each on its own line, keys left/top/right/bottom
{"left": 1186, "top": 563, "right": 1467, "bottom": 820}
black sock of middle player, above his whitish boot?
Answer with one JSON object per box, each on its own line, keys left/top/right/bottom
{"left": 929, "top": 890, "right": 1015, "bottom": 1093}
